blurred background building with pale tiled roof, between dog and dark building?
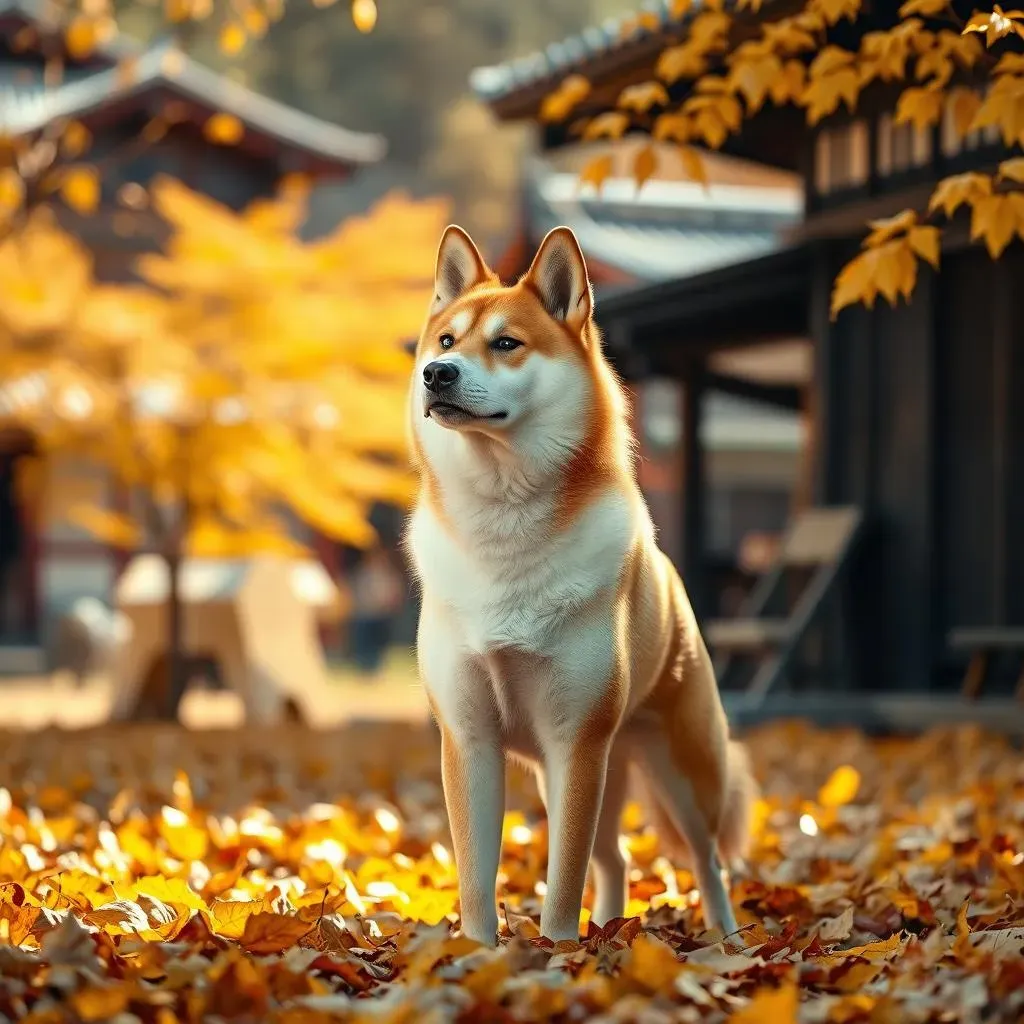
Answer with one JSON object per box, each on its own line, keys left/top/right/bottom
{"left": 492, "top": 149, "right": 810, "bottom": 612}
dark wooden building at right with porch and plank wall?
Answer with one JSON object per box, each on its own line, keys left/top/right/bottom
{"left": 473, "top": 0, "right": 1024, "bottom": 722}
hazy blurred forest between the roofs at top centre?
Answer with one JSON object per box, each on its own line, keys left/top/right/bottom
{"left": 110, "top": 0, "right": 629, "bottom": 245}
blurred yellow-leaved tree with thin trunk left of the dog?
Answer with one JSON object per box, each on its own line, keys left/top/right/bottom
{"left": 0, "top": 179, "right": 447, "bottom": 714}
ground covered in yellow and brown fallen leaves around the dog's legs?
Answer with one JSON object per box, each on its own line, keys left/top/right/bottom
{"left": 0, "top": 724, "right": 1024, "bottom": 1024}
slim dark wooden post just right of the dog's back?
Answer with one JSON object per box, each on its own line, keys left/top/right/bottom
{"left": 679, "top": 361, "right": 707, "bottom": 621}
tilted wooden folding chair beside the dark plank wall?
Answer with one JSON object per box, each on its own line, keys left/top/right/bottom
{"left": 703, "top": 506, "right": 862, "bottom": 698}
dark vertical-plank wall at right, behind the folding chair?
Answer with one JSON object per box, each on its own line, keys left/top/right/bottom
{"left": 812, "top": 237, "right": 1024, "bottom": 688}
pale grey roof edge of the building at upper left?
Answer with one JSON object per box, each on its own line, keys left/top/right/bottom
{"left": 0, "top": 29, "right": 386, "bottom": 164}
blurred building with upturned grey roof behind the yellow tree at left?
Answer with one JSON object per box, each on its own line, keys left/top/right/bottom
{"left": 0, "top": 0, "right": 385, "bottom": 673}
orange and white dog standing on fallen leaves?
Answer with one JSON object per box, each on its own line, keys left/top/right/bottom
{"left": 406, "top": 225, "right": 757, "bottom": 945}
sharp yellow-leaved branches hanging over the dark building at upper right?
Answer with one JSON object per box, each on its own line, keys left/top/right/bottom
{"left": 540, "top": 0, "right": 1024, "bottom": 316}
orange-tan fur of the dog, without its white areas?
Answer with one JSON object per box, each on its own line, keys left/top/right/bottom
{"left": 411, "top": 224, "right": 756, "bottom": 939}
